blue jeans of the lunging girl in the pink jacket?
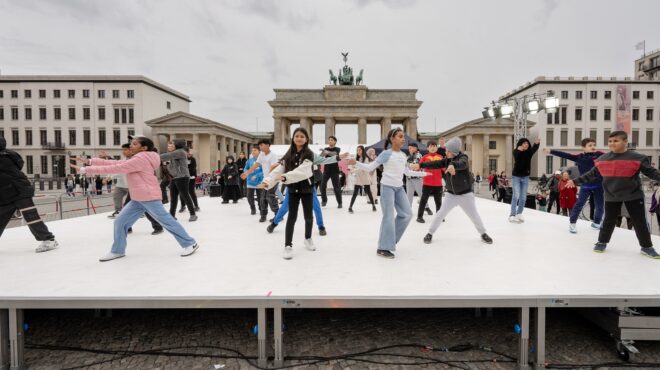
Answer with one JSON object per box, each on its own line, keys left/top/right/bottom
{"left": 111, "top": 200, "right": 196, "bottom": 254}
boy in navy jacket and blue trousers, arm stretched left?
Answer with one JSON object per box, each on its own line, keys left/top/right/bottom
{"left": 544, "top": 138, "right": 605, "bottom": 234}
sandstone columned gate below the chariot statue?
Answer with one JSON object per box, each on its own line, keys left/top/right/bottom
{"left": 268, "top": 85, "right": 422, "bottom": 144}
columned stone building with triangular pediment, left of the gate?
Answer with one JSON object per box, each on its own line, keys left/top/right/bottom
{"left": 146, "top": 112, "right": 260, "bottom": 173}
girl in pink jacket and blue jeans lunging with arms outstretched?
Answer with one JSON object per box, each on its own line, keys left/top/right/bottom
{"left": 71, "top": 137, "right": 199, "bottom": 262}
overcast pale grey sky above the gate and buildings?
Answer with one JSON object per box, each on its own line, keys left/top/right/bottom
{"left": 0, "top": 0, "right": 660, "bottom": 143}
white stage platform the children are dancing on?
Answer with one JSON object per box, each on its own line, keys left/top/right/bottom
{"left": 0, "top": 196, "right": 660, "bottom": 366}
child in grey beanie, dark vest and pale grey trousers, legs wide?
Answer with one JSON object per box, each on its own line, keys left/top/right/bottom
{"left": 411, "top": 138, "right": 493, "bottom": 244}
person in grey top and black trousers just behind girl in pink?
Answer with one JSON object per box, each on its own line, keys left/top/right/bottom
{"left": 160, "top": 139, "right": 197, "bottom": 222}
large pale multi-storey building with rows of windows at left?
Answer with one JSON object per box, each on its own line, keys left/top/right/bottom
{"left": 0, "top": 75, "right": 190, "bottom": 177}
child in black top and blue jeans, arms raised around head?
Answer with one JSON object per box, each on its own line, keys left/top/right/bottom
{"left": 509, "top": 137, "right": 541, "bottom": 224}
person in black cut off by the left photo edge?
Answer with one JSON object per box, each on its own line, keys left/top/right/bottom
{"left": 0, "top": 137, "right": 59, "bottom": 253}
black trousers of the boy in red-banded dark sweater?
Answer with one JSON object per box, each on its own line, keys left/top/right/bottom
{"left": 598, "top": 198, "right": 653, "bottom": 248}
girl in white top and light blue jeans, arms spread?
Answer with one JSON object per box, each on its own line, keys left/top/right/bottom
{"left": 348, "top": 127, "right": 427, "bottom": 258}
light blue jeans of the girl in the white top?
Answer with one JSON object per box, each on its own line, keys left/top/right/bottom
{"left": 378, "top": 184, "right": 412, "bottom": 251}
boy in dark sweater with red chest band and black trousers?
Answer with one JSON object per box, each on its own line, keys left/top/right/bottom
{"left": 567, "top": 131, "right": 660, "bottom": 259}
